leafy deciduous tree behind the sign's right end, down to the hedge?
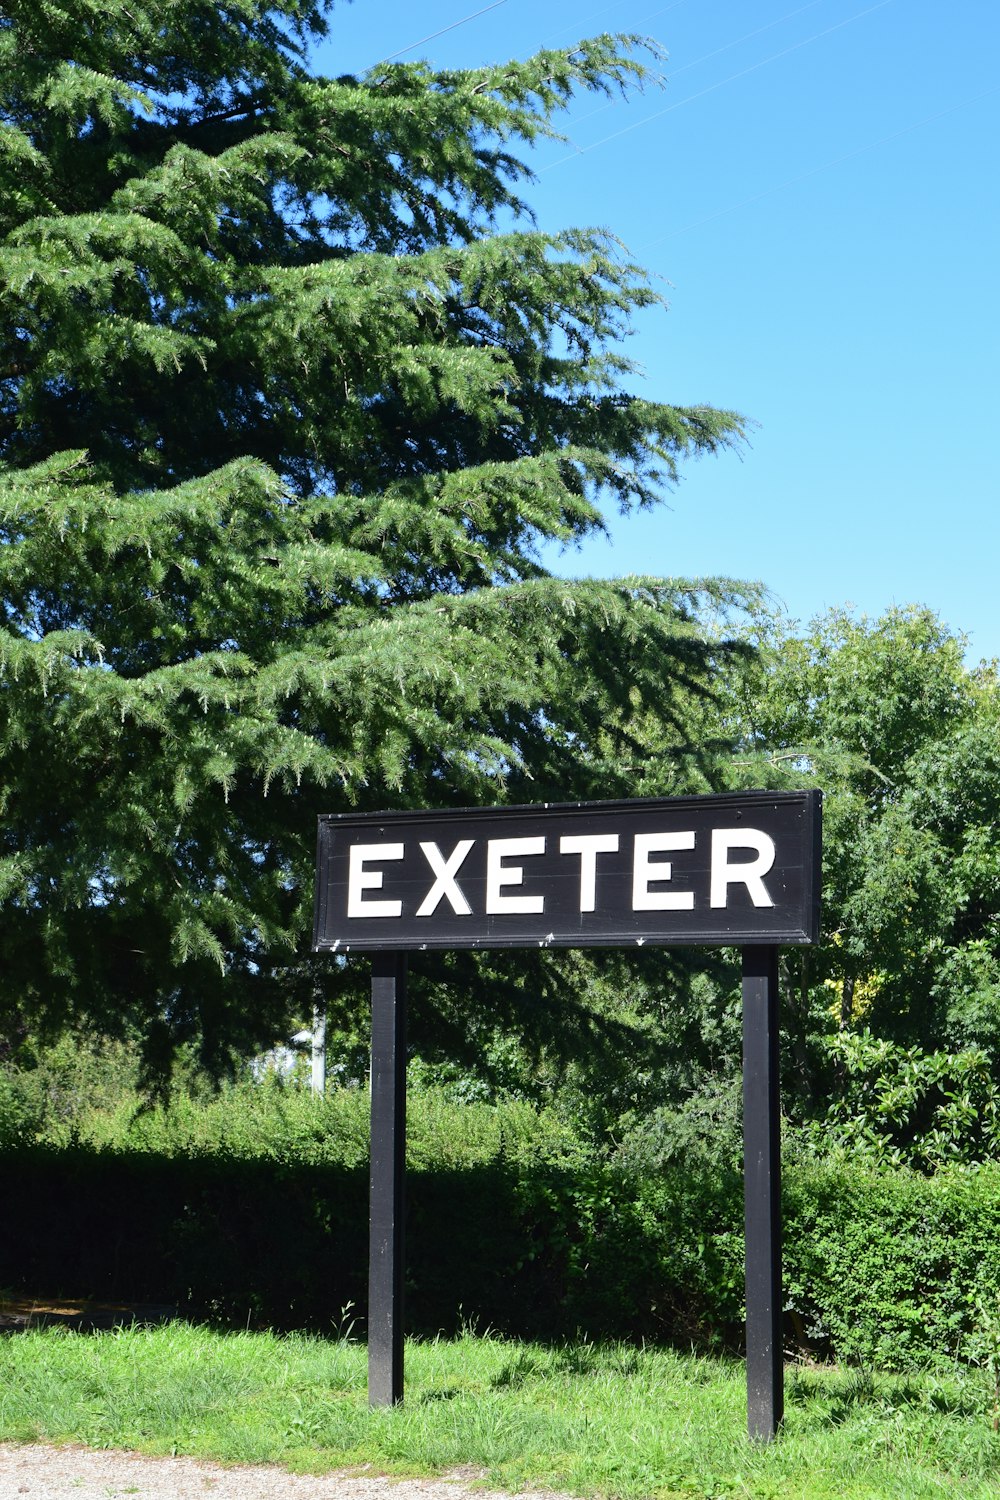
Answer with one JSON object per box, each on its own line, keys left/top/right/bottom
{"left": 602, "top": 606, "right": 1000, "bottom": 1166}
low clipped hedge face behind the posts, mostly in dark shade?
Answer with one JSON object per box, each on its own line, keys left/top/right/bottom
{"left": 0, "top": 1139, "right": 1000, "bottom": 1370}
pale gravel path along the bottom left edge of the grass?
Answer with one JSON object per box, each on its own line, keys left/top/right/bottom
{"left": 0, "top": 1443, "right": 570, "bottom": 1500}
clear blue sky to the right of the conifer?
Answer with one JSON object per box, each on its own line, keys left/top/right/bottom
{"left": 316, "top": 0, "right": 1000, "bottom": 662}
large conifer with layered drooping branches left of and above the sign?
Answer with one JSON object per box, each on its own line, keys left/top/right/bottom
{"left": 0, "top": 0, "right": 742, "bottom": 1058}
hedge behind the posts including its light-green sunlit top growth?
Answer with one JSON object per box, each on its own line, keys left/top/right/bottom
{"left": 0, "top": 1041, "right": 1000, "bottom": 1370}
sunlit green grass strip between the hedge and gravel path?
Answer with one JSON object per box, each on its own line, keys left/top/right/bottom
{"left": 0, "top": 1323, "right": 1000, "bottom": 1500}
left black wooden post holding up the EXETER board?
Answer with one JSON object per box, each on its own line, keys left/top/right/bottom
{"left": 367, "top": 953, "right": 406, "bottom": 1407}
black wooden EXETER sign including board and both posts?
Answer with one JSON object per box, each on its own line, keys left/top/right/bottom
{"left": 313, "top": 791, "right": 820, "bottom": 1442}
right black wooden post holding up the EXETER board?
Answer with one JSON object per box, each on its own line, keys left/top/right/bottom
{"left": 744, "top": 947, "right": 784, "bottom": 1443}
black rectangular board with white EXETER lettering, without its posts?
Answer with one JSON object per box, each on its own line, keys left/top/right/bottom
{"left": 313, "top": 791, "right": 820, "bottom": 953}
